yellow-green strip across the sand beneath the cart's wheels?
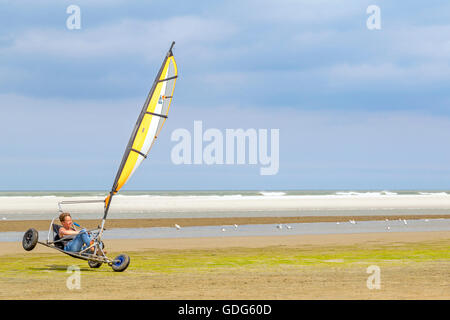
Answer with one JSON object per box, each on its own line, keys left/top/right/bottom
{"left": 0, "top": 240, "right": 450, "bottom": 280}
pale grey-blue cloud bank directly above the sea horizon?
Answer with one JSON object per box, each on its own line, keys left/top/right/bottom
{"left": 0, "top": 89, "right": 450, "bottom": 189}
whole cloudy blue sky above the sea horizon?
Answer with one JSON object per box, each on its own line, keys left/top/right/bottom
{"left": 0, "top": 0, "right": 450, "bottom": 190}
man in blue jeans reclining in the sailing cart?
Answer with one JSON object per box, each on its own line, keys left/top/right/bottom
{"left": 58, "top": 212, "right": 94, "bottom": 252}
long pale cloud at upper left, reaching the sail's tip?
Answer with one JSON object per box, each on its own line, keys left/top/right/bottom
{"left": 0, "top": 16, "right": 236, "bottom": 61}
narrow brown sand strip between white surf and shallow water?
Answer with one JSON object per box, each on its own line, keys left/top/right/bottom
{"left": 0, "top": 214, "right": 450, "bottom": 232}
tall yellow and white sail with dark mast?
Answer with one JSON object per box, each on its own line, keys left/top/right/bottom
{"left": 103, "top": 42, "right": 178, "bottom": 219}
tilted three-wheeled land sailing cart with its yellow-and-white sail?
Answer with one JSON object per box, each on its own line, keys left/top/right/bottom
{"left": 22, "top": 42, "right": 178, "bottom": 271}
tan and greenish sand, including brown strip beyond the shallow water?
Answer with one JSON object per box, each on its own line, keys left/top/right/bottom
{"left": 0, "top": 211, "right": 450, "bottom": 300}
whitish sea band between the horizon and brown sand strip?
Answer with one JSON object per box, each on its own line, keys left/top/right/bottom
{"left": 0, "top": 190, "right": 450, "bottom": 221}
